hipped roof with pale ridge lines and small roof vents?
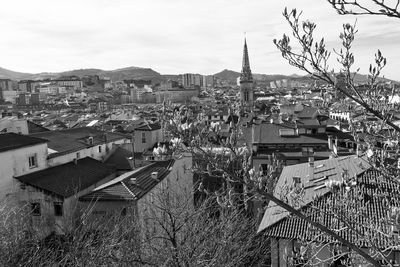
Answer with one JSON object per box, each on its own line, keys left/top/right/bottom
{"left": 80, "top": 160, "right": 175, "bottom": 201}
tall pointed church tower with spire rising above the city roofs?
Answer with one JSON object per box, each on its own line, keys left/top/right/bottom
{"left": 240, "top": 38, "right": 254, "bottom": 109}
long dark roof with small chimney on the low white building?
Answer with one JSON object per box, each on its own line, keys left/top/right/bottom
{"left": 30, "top": 127, "right": 127, "bottom": 157}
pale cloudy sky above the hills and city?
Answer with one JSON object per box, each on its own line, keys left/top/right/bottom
{"left": 0, "top": 0, "right": 400, "bottom": 80}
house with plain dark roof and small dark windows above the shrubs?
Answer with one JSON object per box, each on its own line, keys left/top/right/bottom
{"left": 15, "top": 157, "right": 115, "bottom": 235}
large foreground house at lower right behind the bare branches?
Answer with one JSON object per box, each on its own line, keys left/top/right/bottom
{"left": 258, "top": 155, "right": 400, "bottom": 266}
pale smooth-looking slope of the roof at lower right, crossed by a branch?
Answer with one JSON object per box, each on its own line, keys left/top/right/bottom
{"left": 258, "top": 155, "right": 371, "bottom": 232}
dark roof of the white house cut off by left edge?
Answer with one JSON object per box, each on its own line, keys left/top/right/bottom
{"left": 0, "top": 133, "right": 47, "bottom": 152}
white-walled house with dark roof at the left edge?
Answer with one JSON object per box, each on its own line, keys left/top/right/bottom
{"left": 0, "top": 133, "right": 47, "bottom": 201}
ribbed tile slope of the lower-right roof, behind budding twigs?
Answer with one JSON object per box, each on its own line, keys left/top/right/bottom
{"left": 265, "top": 169, "right": 400, "bottom": 248}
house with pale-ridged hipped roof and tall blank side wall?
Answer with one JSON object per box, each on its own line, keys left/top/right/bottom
{"left": 79, "top": 154, "right": 194, "bottom": 230}
